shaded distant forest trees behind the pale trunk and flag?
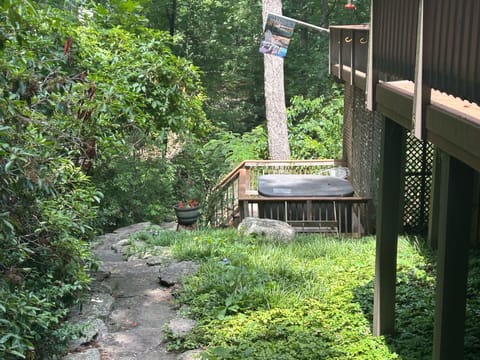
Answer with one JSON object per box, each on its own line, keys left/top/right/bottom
{"left": 145, "top": 0, "right": 370, "bottom": 132}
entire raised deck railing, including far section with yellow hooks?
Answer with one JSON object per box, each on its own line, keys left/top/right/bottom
{"left": 330, "top": 0, "right": 480, "bottom": 104}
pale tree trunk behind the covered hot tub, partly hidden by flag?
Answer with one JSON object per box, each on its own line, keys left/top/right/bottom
{"left": 262, "top": 0, "right": 290, "bottom": 160}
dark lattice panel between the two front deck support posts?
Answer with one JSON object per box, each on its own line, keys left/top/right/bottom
{"left": 403, "top": 135, "right": 434, "bottom": 233}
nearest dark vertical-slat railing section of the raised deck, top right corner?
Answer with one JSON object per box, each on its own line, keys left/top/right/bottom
{"left": 372, "top": 0, "right": 480, "bottom": 103}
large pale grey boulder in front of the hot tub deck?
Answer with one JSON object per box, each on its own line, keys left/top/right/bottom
{"left": 238, "top": 217, "right": 295, "bottom": 243}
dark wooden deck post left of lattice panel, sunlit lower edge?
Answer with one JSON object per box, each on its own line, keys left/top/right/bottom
{"left": 373, "top": 118, "right": 406, "bottom": 336}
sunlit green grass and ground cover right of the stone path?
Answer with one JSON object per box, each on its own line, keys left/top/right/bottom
{"left": 128, "top": 230, "right": 480, "bottom": 360}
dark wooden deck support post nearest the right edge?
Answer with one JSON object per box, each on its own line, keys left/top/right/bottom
{"left": 433, "top": 156, "right": 475, "bottom": 360}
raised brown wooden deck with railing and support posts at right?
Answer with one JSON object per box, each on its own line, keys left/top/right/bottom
{"left": 330, "top": 4, "right": 480, "bottom": 360}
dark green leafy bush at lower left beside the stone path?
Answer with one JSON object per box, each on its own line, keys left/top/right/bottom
{"left": 0, "top": 127, "right": 99, "bottom": 358}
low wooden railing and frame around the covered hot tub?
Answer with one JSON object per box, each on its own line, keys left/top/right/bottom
{"left": 210, "top": 160, "right": 370, "bottom": 236}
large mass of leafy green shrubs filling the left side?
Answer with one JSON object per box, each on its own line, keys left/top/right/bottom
{"left": 0, "top": 0, "right": 209, "bottom": 359}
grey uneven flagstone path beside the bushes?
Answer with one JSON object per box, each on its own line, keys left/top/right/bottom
{"left": 64, "top": 223, "right": 199, "bottom": 360}
